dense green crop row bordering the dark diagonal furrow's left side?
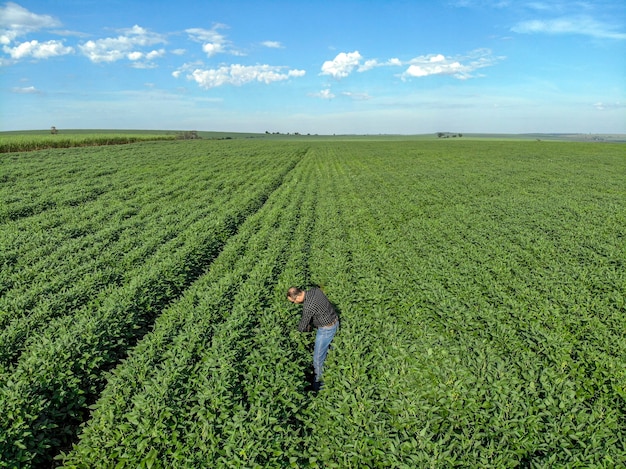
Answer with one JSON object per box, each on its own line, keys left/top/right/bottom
{"left": 0, "top": 139, "right": 308, "bottom": 467}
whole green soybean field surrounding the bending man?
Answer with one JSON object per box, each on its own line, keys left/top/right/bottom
{"left": 0, "top": 138, "right": 626, "bottom": 469}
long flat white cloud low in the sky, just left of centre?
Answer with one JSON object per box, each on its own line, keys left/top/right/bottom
{"left": 185, "top": 64, "right": 305, "bottom": 89}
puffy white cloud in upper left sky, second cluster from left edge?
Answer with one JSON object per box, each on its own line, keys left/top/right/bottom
{"left": 79, "top": 25, "right": 166, "bottom": 63}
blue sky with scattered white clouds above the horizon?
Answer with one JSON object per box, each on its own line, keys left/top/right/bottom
{"left": 0, "top": 0, "right": 626, "bottom": 134}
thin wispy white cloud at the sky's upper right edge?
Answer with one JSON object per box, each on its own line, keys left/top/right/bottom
{"left": 511, "top": 16, "right": 626, "bottom": 39}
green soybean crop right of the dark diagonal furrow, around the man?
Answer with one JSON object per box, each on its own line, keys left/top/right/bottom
{"left": 57, "top": 141, "right": 625, "bottom": 468}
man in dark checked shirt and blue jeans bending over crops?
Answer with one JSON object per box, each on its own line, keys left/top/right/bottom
{"left": 287, "top": 287, "right": 339, "bottom": 391}
